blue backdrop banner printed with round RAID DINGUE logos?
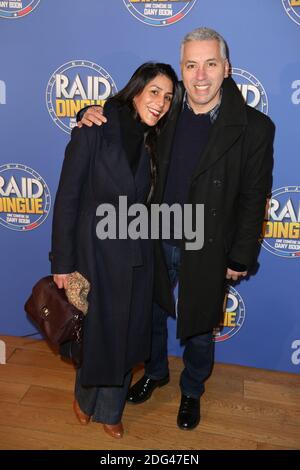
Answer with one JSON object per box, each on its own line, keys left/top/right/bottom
{"left": 0, "top": 0, "right": 300, "bottom": 373}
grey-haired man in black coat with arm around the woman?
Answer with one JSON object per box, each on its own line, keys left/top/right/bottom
{"left": 77, "top": 28, "right": 274, "bottom": 429}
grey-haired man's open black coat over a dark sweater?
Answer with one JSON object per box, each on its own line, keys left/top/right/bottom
{"left": 155, "top": 77, "right": 275, "bottom": 338}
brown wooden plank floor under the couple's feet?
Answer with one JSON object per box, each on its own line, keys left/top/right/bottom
{"left": 0, "top": 337, "right": 300, "bottom": 450}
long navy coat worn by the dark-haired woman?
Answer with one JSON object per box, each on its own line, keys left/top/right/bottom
{"left": 50, "top": 104, "right": 152, "bottom": 386}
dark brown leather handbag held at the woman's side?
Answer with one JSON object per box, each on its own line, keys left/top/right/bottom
{"left": 24, "top": 276, "right": 84, "bottom": 346}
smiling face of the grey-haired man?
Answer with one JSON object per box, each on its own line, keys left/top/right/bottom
{"left": 181, "top": 39, "right": 229, "bottom": 114}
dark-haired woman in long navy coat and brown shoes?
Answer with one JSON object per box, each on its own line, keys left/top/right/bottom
{"left": 50, "top": 63, "right": 178, "bottom": 437}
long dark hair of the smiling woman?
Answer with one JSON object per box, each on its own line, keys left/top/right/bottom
{"left": 109, "top": 62, "right": 180, "bottom": 203}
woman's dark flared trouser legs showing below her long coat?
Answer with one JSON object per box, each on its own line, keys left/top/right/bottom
{"left": 75, "top": 369, "right": 132, "bottom": 424}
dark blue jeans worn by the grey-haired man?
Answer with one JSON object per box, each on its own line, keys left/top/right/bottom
{"left": 145, "top": 242, "right": 214, "bottom": 399}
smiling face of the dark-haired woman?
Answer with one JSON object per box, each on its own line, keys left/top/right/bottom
{"left": 133, "top": 75, "right": 173, "bottom": 126}
